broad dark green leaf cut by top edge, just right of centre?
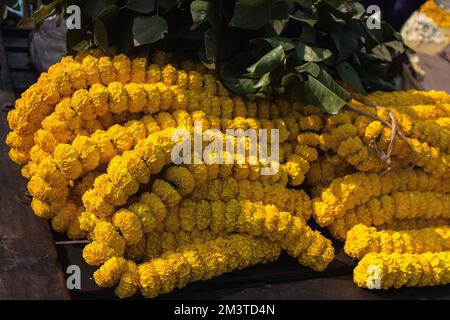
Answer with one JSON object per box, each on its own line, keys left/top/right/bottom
{"left": 229, "top": 0, "right": 271, "bottom": 30}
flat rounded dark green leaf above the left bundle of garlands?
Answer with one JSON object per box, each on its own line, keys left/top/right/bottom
{"left": 133, "top": 16, "right": 168, "bottom": 47}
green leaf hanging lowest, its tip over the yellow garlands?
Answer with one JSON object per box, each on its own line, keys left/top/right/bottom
{"left": 305, "top": 75, "right": 346, "bottom": 114}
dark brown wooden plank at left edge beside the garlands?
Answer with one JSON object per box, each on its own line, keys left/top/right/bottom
{"left": 0, "top": 113, "right": 70, "bottom": 299}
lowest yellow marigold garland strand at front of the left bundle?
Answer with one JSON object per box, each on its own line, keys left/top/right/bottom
{"left": 100, "top": 235, "right": 280, "bottom": 298}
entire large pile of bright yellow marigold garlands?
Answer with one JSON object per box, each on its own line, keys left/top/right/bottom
{"left": 7, "top": 51, "right": 450, "bottom": 298}
